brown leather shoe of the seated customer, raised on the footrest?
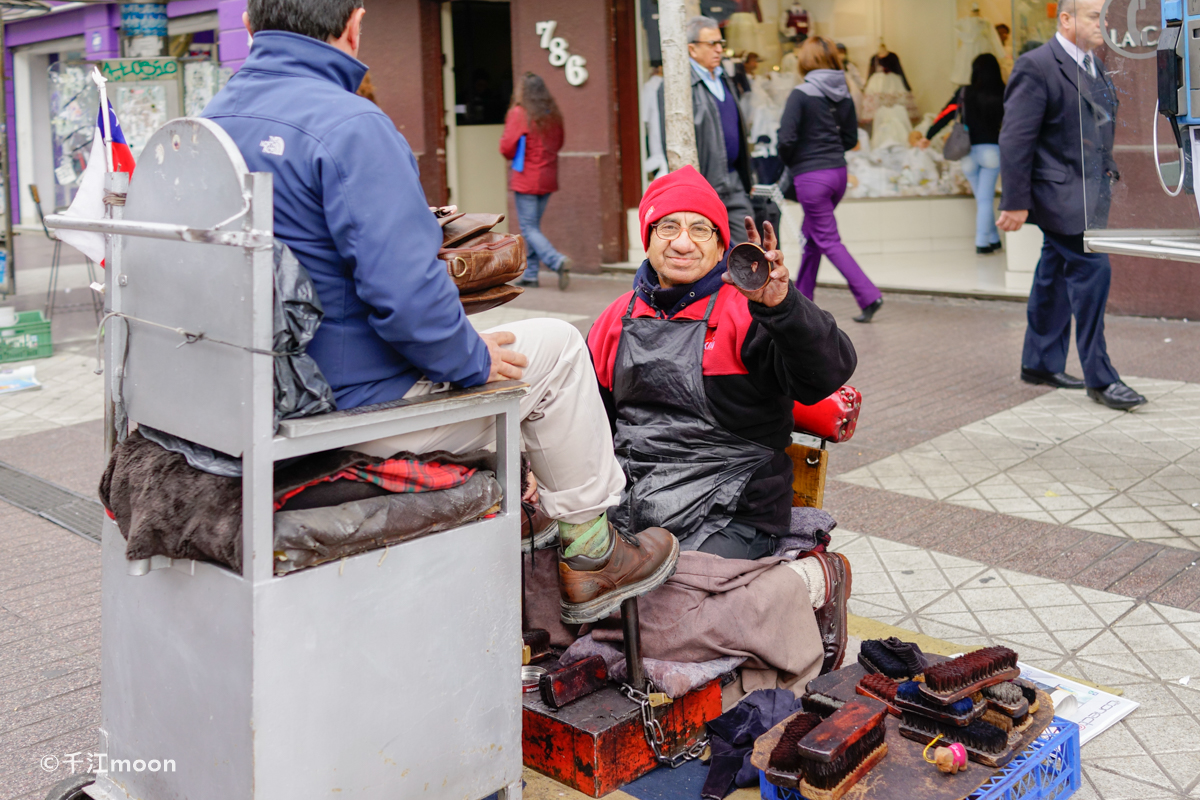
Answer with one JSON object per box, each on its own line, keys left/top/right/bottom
{"left": 558, "top": 525, "right": 679, "bottom": 625}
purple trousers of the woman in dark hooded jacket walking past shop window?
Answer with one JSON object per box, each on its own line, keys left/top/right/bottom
{"left": 792, "top": 167, "right": 883, "bottom": 308}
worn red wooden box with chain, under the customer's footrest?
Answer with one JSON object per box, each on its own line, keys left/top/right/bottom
{"left": 522, "top": 680, "right": 721, "bottom": 798}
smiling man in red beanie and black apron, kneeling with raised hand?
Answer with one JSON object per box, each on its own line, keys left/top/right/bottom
{"left": 583, "top": 167, "right": 857, "bottom": 678}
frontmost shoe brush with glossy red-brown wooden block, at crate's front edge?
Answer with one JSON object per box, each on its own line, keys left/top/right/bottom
{"left": 798, "top": 697, "right": 888, "bottom": 800}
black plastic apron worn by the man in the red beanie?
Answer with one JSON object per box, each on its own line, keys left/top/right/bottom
{"left": 610, "top": 293, "right": 774, "bottom": 549}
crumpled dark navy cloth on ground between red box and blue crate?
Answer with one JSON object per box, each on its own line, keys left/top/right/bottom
{"left": 700, "top": 688, "right": 802, "bottom": 800}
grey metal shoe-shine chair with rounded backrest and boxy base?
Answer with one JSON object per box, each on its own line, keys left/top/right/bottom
{"left": 47, "top": 119, "right": 526, "bottom": 800}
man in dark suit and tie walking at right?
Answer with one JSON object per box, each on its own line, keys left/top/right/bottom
{"left": 996, "top": 0, "right": 1146, "bottom": 409}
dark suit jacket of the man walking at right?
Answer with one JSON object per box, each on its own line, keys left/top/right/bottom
{"left": 1000, "top": 38, "right": 1120, "bottom": 235}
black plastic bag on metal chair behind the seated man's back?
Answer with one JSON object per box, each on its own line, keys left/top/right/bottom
{"left": 271, "top": 239, "right": 337, "bottom": 428}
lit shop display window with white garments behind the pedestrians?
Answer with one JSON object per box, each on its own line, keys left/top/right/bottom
{"left": 640, "top": 0, "right": 1017, "bottom": 199}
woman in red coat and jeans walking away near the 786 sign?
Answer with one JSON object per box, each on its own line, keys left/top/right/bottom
{"left": 500, "top": 72, "right": 571, "bottom": 289}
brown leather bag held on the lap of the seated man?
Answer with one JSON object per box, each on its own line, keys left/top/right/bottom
{"left": 433, "top": 206, "right": 526, "bottom": 314}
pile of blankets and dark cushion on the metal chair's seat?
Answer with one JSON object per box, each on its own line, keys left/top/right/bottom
{"left": 100, "top": 431, "right": 503, "bottom": 573}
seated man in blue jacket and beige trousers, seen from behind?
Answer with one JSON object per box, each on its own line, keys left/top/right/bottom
{"left": 204, "top": 0, "right": 678, "bottom": 620}
